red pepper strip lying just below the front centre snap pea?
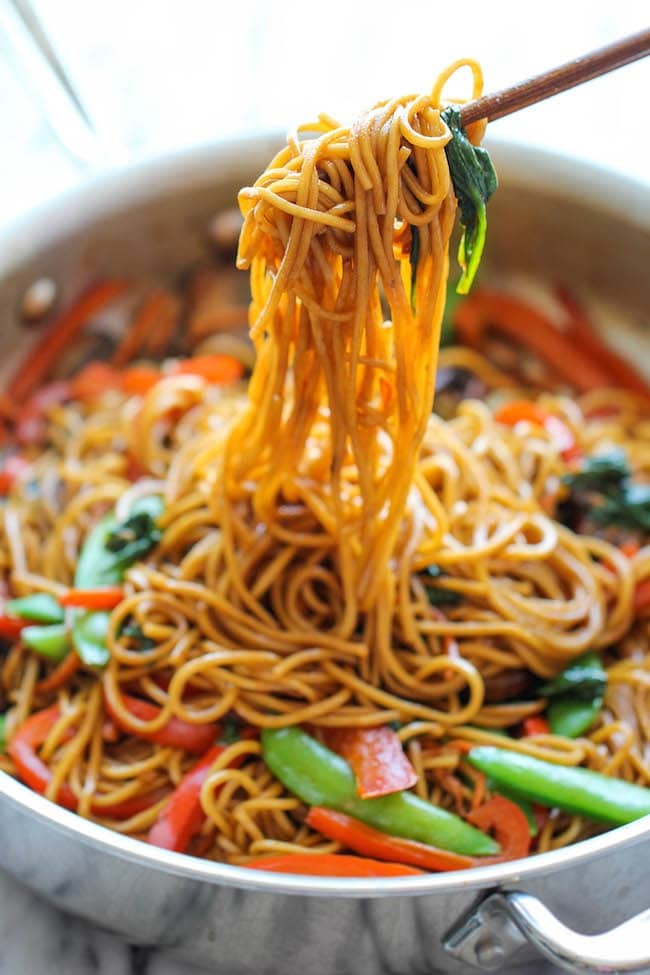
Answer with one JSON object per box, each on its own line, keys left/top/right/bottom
{"left": 306, "top": 806, "right": 478, "bottom": 870}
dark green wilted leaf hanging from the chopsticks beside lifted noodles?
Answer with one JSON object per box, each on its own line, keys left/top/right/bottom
{"left": 442, "top": 105, "right": 498, "bottom": 294}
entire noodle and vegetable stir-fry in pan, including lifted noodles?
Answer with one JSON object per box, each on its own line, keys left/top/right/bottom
{"left": 0, "top": 62, "right": 650, "bottom": 877}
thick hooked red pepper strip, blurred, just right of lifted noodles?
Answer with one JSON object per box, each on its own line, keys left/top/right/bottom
{"left": 454, "top": 289, "right": 612, "bottom": 393}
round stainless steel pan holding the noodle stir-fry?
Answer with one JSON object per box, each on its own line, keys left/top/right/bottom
{"left": 0, "top": 138, "right": 650, "bottom": 975}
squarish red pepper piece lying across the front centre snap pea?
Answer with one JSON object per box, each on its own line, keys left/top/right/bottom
{"left": 325, "top": 725, "right": 417, "bottom": 799}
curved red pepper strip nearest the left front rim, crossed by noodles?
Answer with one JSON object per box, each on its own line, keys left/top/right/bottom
{"left": 7, "top": 705, "right": 167, "bottom": 819}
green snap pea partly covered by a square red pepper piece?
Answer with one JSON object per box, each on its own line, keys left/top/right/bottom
{"left": 262, "top": 728, "right": 499, "bottom": 856}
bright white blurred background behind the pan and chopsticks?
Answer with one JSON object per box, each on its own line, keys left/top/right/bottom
{"left": 0, "top": 0, "right": 650, "bottom": 219}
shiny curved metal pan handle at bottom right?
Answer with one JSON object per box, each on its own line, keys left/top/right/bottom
{"left": 444, "top": 891, "right": 650, "bottom": 975}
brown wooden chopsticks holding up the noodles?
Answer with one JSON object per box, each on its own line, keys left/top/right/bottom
{"left": 460, "top": 29, "right": 650, "bottom": 126}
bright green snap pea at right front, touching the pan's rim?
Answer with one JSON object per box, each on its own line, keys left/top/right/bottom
{"left": 467, "top": 745, "right": 650, "bottom": 826}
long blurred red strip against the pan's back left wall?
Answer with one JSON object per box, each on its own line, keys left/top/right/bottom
{"left": 7, "top": 280, "right": 126, "bottom": 402}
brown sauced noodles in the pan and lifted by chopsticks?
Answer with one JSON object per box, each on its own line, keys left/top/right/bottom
{"left": 0, "top": 61, "right": 650, "bottom": 864}
